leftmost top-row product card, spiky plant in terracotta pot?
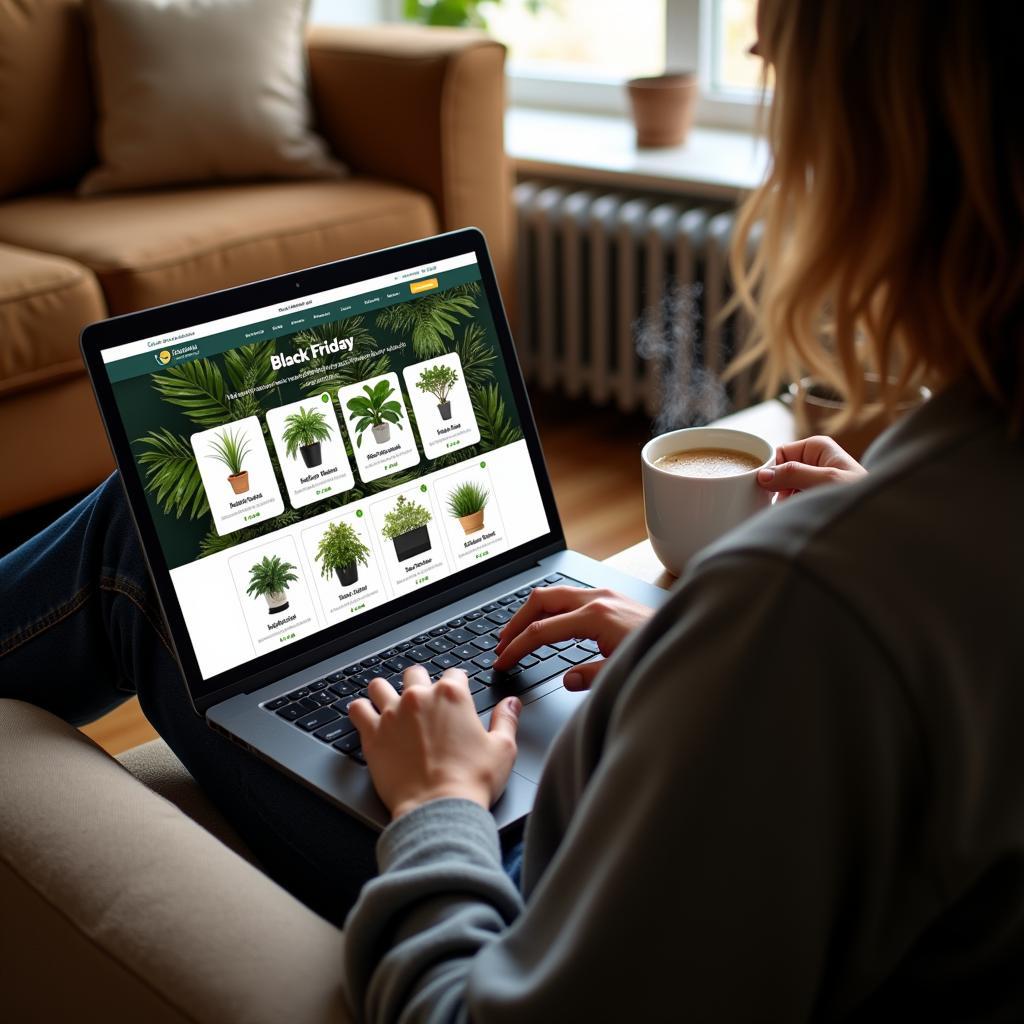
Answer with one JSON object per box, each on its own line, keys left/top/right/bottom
{"left": 190, "top": 416, "right": 285, "bottom": 537}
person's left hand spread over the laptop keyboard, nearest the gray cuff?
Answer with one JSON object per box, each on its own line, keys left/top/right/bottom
{"left": 348, "top": 665, "right": 522, "bottom": 818}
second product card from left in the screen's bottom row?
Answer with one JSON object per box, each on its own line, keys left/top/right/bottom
{"left": 302, "top": 511, "right": 389, "bottom": 623}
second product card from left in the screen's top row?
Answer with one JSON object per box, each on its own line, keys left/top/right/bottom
{"left": 266, "top": 391, "right": 355, "bottom": 508}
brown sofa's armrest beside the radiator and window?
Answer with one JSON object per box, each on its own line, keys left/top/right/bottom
{"left": 309, "top": 26, "right": 512, "bottom": 287}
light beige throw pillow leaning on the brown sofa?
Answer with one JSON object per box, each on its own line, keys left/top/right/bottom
{"left": 80, "top": 0, "right": 341, "bottom": 195}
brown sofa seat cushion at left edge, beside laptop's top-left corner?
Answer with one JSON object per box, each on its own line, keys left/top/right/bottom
{"left": 0, "top": 244, "right": 106, "bottom": 395}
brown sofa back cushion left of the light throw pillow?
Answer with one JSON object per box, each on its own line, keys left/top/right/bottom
{"left": 0, "top": 0, "right": 95, "bottom": 198}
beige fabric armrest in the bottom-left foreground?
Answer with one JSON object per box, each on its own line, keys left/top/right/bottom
{"left": 0, "top": 700, "right": 349, "bottom": 1024}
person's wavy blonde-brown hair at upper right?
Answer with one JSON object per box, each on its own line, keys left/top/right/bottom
{"left": 731, "top": 0, "right": 1024, "bottom": 426}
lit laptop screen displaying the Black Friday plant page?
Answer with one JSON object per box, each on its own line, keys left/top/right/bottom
{"left": 101, "top": 252, "right": 551, "bottom": 680}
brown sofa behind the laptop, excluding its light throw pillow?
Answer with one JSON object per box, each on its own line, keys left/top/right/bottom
{"left": 0, "top": 0, "right": 512, "bottom": 517}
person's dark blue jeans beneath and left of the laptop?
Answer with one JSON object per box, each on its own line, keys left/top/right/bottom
{"left": 0, "top": 473, "right": 521, "bottom": 926}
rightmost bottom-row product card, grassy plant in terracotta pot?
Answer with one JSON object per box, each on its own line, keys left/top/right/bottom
{"left": 434, "top": 459, "right": 508, "bottom": 569}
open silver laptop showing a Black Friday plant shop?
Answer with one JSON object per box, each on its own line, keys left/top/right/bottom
{"left": 82, "top": 228, "right": 665, "bottom": 829}
